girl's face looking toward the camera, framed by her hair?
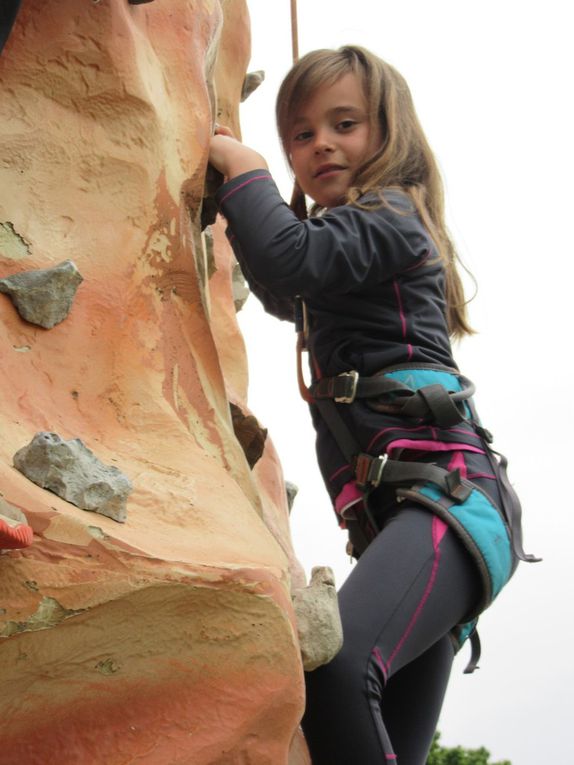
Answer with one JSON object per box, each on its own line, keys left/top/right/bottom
{"left": 289, "top": 73, "right": 382, "bottom": 207}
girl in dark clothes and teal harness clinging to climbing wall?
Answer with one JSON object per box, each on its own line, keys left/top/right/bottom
{"left": 210, "top": 46, "right": 536, "bottom": 765}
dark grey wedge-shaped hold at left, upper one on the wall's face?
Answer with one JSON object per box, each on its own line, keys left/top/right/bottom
{"left": 0, "top": 260, "right": 83, "bottom": 329}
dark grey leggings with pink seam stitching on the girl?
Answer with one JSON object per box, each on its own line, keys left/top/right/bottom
{"left": 302, "top": 503, "right": 480, "bottom": 765}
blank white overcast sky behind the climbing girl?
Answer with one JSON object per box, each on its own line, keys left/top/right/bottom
{"left": 236, "top": 0, "right": 574, "bottom": 765}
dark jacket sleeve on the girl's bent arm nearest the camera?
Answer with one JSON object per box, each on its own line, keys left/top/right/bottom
{"left": 216, "top": 170, "right": 429, "bottom": 298}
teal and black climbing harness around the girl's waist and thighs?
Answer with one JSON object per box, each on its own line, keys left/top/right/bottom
{"left": 295, "top": 298, "right": 540, "bottom": 672}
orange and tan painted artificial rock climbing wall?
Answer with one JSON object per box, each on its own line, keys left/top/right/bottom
{"left": 0, "top": 0, "right": 308, "bottom": 765}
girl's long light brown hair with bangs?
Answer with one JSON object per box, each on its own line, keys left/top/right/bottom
{"left": 276, "top": 45, "right": 474, "bottom": 338}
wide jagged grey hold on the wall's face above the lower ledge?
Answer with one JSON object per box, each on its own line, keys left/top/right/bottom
{"left": 14, "top": 432, "right": 132, "bottom": 522}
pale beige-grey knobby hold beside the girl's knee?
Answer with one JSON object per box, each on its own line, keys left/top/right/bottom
{"left": 293, "top": 566, "right": 343, "bottom": 672}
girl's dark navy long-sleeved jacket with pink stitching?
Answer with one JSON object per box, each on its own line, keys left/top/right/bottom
{"left": 216, "top": 170, "right": 468, "bottom": 500}
